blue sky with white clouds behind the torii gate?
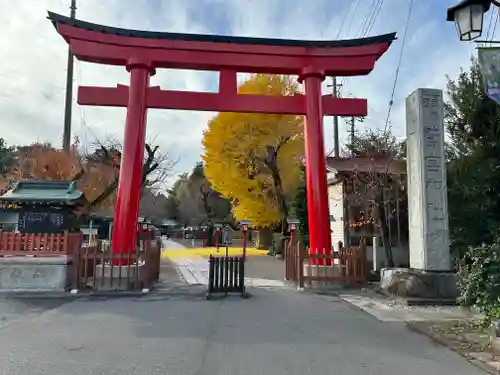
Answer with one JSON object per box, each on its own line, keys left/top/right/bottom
{"left": 0, "top": 0, "right": 490, "bottom": 187}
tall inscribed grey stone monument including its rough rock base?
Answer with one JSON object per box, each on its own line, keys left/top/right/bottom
{"left": 381, "top": 88, "right": 458, "bottom": 302}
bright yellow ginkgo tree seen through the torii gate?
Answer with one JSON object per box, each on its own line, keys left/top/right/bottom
{"left": 203, "top": 74, "right": 304, "bottom": 232}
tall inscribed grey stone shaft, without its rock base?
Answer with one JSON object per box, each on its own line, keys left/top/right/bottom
{"left": 406, "top": 89, "right": 451, "bottom": 271}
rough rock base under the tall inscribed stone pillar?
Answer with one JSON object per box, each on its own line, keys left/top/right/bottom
{"left": 380, "top": 268, "right": 459, "bottom": 304}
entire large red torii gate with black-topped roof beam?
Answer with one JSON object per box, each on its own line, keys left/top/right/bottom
{"left": 48, "top": 12, "right": 396, "bottom": 264}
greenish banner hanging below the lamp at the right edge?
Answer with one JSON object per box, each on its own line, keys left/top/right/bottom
{"left": 478, "top": 47, "right": 500, "bottom": 104}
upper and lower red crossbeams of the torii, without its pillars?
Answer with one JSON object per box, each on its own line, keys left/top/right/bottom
{"left": 49, "top": 12, "right": 396, "bottom": 116}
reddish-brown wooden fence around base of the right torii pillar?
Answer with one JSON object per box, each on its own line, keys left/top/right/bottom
{"left": 285, "top": 239, "right": 367, "bottom": 288}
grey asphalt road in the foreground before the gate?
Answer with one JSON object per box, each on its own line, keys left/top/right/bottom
{"left": 0, "top": 289, "right": 484, "bottom": 375}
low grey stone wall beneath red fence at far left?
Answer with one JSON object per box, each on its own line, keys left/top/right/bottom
{"left": 0, "top": 256, "right": 72, "bottom": 292}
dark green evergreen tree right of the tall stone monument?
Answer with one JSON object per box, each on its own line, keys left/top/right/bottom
{"left": 445, "top": 59, "right": 500, "bottom": 257}
